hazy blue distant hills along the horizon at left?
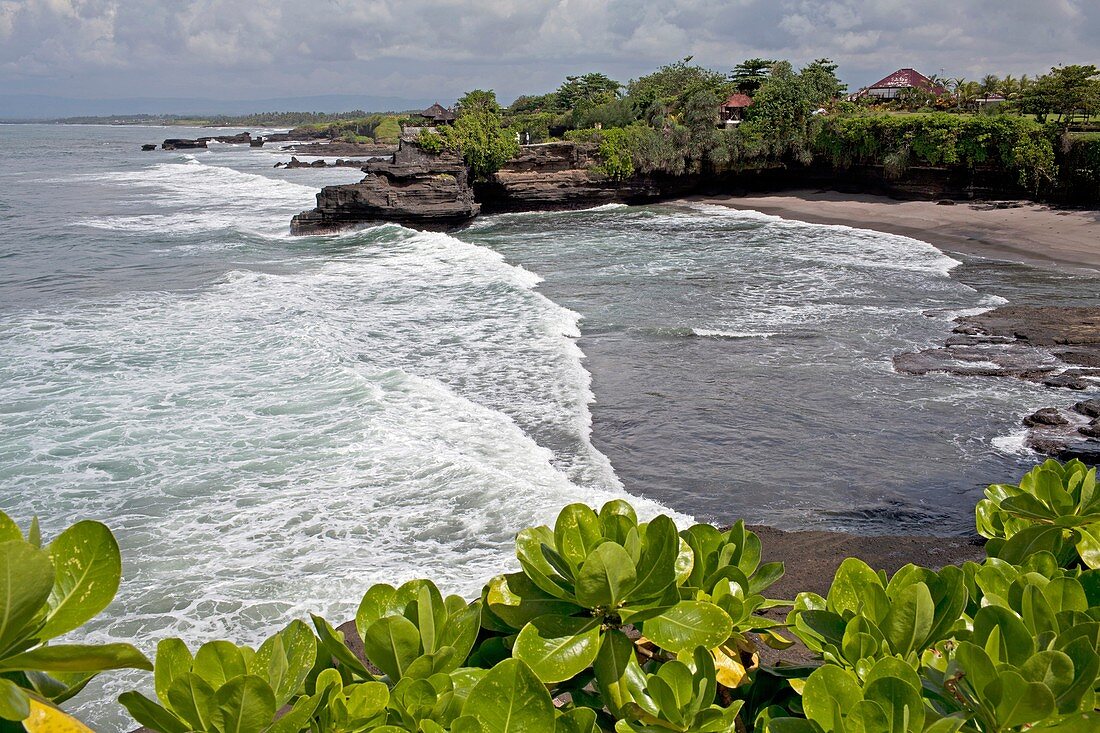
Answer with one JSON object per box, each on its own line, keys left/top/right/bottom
{"left": 0, "top": 95, "right": 437, "bottom": 121}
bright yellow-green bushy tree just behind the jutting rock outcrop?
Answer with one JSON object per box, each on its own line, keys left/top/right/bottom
{"left": 441, "top": 89, "right": 519, "bottom": 178}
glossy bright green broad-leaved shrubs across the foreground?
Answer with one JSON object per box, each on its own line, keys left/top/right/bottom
{"left": 8, "top": 460, "right": 1100, "bottom": 733}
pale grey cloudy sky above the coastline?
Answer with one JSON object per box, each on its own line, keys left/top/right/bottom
{"left": 0, "top": 0, "right": 1100, "bottom": 107}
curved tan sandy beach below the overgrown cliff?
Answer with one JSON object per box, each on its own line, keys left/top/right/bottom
{"left": 685, "top": 190, "right": 1100, "bottom": 270}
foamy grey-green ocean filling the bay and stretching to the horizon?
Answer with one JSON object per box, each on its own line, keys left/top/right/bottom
{"left": 0, "top": 125, "right": 1100, "bottom": 731}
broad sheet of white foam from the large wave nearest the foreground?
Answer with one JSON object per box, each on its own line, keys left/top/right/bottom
{"left": 0, "top": 224, "right": 684, "bottom": 641}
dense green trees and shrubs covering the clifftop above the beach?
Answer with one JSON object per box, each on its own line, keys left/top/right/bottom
{"left": 484, "top": 57, "right": 1100, "bottom": 200}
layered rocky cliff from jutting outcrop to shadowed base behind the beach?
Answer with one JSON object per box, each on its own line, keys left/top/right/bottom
{"left": 292, "top": 141, "right": 1047, "bottom": 233}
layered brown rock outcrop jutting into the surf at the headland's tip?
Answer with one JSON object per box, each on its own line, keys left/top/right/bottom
{"left": 290, "top": 144, "right": 481, "bottom": 234}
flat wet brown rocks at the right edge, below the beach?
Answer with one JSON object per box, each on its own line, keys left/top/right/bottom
{"left": 894, "top": 306, "right": 1100, "bottom": 464}
